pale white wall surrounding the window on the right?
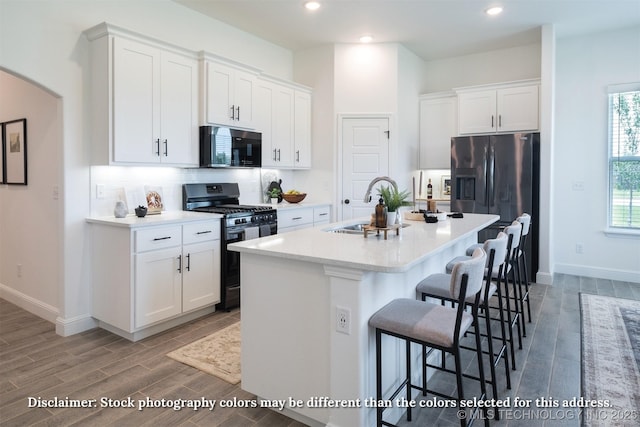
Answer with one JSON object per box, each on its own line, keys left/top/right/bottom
{"left": 553, "top": 27, "right": 640, "bottom": 282}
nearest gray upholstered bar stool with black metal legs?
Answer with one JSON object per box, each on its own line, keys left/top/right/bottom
{"left": 369, "top": 249, "right": 489, "bottom": 427}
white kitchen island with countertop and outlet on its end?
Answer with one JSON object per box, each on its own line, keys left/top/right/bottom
{"left": 229, "top": 214, "right": 498, "bottom": 427}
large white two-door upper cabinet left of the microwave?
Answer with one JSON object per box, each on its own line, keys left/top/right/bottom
{"left": 87, "top": 24, "right": 198, "bottom": 166}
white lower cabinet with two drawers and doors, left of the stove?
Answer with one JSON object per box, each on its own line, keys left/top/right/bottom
{"left": 92, "top": 219, "right": 221, "bottom": 341}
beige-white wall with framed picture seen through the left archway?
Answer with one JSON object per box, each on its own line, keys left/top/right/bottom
{"left": 0, "top": 69, "right": 62, "bottom": 321}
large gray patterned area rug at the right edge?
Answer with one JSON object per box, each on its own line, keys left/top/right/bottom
{"left": 580, "top": 294, "right": 640, "bottom": 426}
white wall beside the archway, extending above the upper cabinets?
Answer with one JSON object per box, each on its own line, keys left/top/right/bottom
{"left": 0, "top": 0, "right": 293, "bottom": 335}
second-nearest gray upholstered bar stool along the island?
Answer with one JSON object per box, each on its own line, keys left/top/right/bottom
{"left": 416, "top": 232, "right": 511, "bottom": 406}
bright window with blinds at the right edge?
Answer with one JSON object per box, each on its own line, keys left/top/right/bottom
{"left": 609, "top": 83, "right": 640, "bottom": 230}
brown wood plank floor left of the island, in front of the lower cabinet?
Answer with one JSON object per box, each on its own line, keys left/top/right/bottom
{"left": 0, "top": 299, "right": 302, "bottom": 427}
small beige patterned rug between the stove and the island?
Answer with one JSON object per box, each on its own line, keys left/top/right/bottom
{"left": 167, "top": 322, "right": 241, "bottom": 384}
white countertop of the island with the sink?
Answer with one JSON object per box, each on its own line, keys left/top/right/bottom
{"left": 228, "top": 214, "right": 499, "bottom": 273}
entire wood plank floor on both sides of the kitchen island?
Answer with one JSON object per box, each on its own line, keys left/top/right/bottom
{"left": 0, "top": 275, "right": 640, "bottom": 427}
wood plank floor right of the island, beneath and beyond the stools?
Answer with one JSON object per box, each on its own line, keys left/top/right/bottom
{"left": 400, "top": 274, "right": 640, "bottom": 427}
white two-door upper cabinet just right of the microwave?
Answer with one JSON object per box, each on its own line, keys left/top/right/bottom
{"left": 255, "top": 78, "right": 311, "bottom": 169}
